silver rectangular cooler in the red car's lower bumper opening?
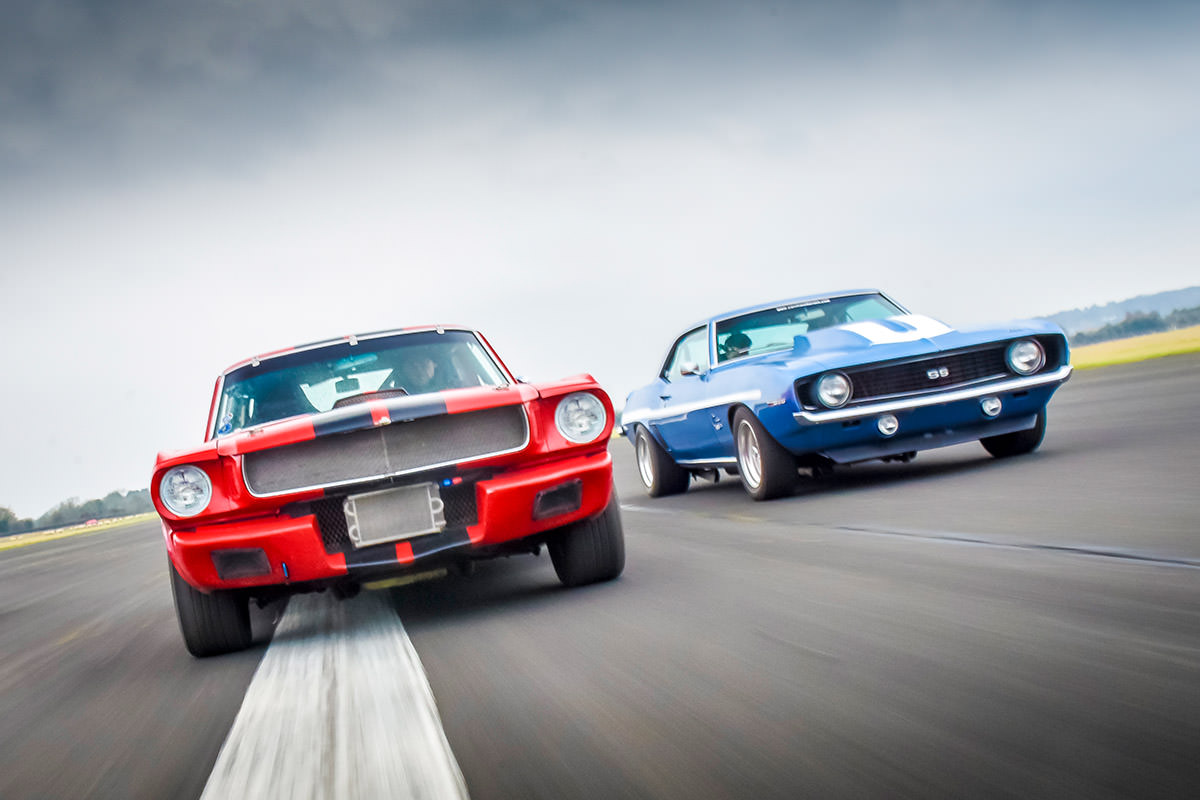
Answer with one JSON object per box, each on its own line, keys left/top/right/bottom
{"left": 342, "top": 483, "right": 446, "bottom": 547}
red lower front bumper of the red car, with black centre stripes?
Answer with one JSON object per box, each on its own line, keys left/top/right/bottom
{"left": 163, "top": 451, "right": 612, "bottom": 591}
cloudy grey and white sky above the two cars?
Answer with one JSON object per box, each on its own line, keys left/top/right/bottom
{"left": 0, "top": 0, "right": 1200, "bottom": 516}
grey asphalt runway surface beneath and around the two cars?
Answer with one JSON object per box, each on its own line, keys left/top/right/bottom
{"left": 0, "top": 356, "right": 1200, "bottom": 800}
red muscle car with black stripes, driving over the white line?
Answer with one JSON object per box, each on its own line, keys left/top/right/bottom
{"left": 150, "top": 326, "right": 625, "bottom": 656}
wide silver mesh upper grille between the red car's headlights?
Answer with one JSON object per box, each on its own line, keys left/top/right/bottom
{"left": 242, "top": 405, "right": 529, "bottom": 497}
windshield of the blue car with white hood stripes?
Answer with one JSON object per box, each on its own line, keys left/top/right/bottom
{"left": 716, "top": 294, "right": 904, "bottom": 363}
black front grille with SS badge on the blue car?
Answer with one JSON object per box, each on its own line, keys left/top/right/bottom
{"left": 846, "top": 345, "right": 1008, "bottom": 401}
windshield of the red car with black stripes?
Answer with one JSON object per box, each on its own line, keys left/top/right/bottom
{"left": 212, "top": 331, "right": 508, "bottom": 435}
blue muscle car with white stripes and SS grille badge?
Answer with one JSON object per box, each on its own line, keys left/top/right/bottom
{"left": 620, "top": 290, "right": 1072, "bottom": 500}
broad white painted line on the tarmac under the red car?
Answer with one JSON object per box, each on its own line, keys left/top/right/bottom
{"left": 202, "top": 591, "right": 468, "bottom": 800}
